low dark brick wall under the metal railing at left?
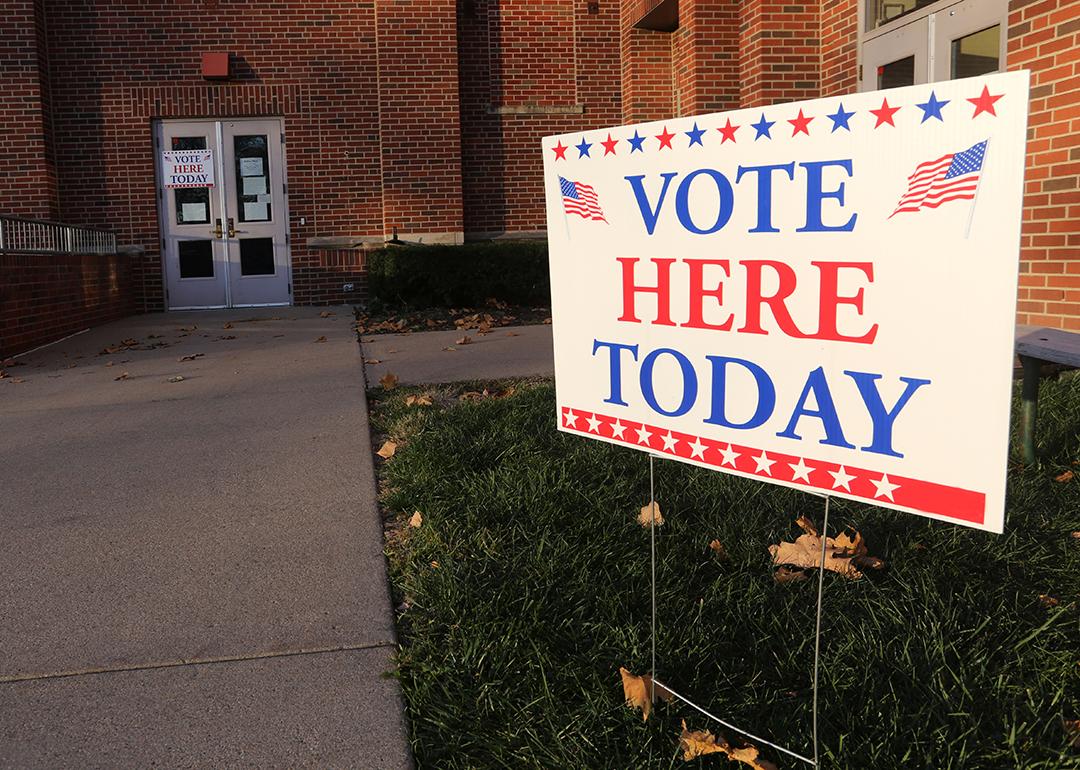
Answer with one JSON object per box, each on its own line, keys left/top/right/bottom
{"left": 0, "top": 254, "right": 135, "bottom": 359}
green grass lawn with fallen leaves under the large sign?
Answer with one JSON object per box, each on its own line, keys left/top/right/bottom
{"left": 370, "top": 375, "right": 1080, "bottom": 770}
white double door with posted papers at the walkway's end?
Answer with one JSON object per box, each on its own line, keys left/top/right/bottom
{"left": 156, "top": 119, "right": 292, "bottom": 310}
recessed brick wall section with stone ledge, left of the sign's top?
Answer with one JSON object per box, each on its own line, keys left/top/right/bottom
{"left": 458, "top": 0, "right": 622, "bottom": 235}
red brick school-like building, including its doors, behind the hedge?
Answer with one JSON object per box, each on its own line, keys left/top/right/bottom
{"left": 0, "top": 0, "right": 1080, "bottom": 328}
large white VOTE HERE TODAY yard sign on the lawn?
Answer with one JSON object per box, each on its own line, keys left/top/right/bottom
{"left": 542, "top": 72, "right": 1028, "bottom": 532}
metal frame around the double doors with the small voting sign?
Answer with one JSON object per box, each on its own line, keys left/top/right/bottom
{"left": 151, "top": 116, "right": 295, "bottom": 310}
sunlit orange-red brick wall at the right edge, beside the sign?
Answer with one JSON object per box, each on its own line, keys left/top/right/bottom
{"left": 1008, "top": 0, "right": 1080, "bottom": 332}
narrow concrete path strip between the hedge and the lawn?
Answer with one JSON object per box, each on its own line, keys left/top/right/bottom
{"left": 363, "top": 324, "right": 555, "bottom": 387}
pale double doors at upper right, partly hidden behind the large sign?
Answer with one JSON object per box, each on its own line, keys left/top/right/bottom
{"left": 860, "top": 0, "right": 1008, "bottom": 91}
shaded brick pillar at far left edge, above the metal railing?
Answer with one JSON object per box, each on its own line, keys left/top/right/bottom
{"left": 0, "top": 0, "right": 56, "bottom": 219}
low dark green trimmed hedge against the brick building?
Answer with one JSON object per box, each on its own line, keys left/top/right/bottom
{"left": 367, "top": 241, "right": 551, "bottom": 308}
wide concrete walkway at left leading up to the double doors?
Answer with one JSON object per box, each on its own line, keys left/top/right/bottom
{"left": 0, "top": 308, "right": 410, "bottom": 768}
